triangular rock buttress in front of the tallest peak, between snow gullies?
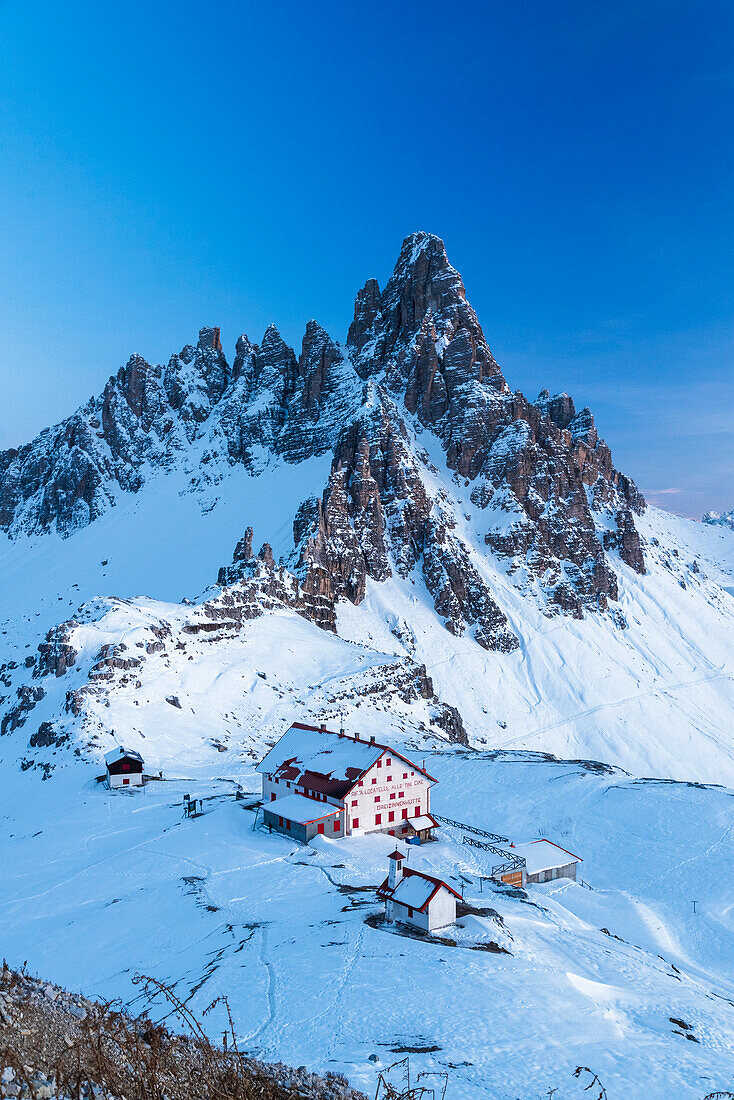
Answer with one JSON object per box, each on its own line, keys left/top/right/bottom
{"left": 294, "top": 387, "right": 517, "bottom": 651}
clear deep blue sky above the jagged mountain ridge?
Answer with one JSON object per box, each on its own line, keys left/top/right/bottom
{"left": 0, "top": 0, "right": 734, "bottom": 515}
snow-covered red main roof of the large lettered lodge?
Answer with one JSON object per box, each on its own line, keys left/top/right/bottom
{"left": 258, "top": 723, "right": 435, "bottom": 798}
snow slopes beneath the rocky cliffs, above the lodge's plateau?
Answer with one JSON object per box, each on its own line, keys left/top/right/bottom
{"left": 0, "top": 413, "right": 734, "bottom": 785}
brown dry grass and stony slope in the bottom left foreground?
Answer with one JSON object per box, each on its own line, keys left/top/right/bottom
{"left": 0, "top": 963, "right": 365, "bottom": 1100}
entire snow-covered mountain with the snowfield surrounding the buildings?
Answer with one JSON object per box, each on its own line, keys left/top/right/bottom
{"left": 0, "top": 233, "right": 734, "bottom": 1100}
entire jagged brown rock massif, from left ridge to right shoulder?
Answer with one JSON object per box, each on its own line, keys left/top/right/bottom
{"left": 0, "top": 232, "right": 645, "bottom": 629}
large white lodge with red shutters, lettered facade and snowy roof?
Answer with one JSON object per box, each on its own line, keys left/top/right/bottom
{"left": 258, "top": 723, "right": 437, "bottom": 842}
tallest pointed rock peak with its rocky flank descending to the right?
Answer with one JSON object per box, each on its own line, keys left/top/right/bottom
{"left": 348, "top": 233, "right": 645, "bottom": 615}
